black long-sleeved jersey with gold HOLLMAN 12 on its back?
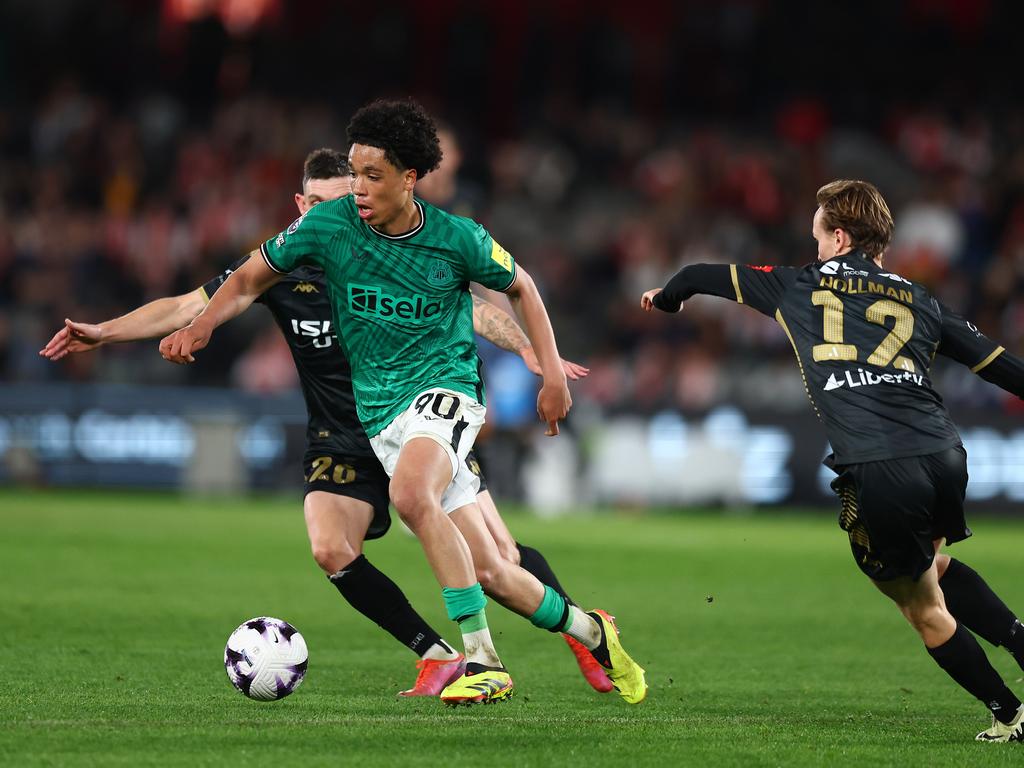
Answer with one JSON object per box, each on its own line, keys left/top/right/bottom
{"left": 655, "top": 252, "right": 1019, "bottom": 464}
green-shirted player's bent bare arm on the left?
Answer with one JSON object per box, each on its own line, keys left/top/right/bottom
{"left": 160, "top": 251, "right": 284, "bottom": 364}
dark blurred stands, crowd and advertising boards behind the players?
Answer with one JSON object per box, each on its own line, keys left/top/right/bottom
{"left": 0, "top": 0, "right": 1024, "bottom": 509}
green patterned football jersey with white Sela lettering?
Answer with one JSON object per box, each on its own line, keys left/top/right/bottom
{"left": 260, "top": 195, "right": 515, "bottom": 437}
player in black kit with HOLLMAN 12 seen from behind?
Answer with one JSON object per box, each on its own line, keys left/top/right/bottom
{"left": 641, "top": 180, "right": 1024, "bottom": 741}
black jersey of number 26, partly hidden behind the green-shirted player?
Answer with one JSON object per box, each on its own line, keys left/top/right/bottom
{"left": 203, "top": 257, "right": 374, "bottom": 459}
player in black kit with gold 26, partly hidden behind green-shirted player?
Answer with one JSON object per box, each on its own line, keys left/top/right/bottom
{"left": 40, "top": 148, "right": 612, "bottom": 696}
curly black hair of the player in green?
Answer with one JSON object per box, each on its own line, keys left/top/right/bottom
{"left": 347, "top": 98, "right": 441, "bottom": 178}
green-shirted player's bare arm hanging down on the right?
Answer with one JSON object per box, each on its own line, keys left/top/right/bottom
{"left": 505, "top": 266, "right": 572, "bottom": 436}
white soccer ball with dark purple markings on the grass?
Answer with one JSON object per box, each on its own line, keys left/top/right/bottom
{"left": 224, "top": 616, "right": 309, "bottom": 701}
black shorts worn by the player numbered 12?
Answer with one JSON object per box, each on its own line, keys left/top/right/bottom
{"left": 826, "top": 445, "right": 971, "bottom": 582}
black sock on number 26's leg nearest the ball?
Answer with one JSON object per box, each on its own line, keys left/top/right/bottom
{"left": 328, "top": 555, "right": 451, "bottom": 656}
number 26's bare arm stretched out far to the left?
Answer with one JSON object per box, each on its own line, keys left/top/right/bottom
{"left": 39, "top": 288, "right": 206, "bottom": 360}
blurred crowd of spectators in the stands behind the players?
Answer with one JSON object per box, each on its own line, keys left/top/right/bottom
{"left": 0, "top": 1, "right": 1024, "bottom": 421}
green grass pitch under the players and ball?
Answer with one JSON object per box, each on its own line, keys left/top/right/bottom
{"left": 0, "top": 490, "right": 1024, "bottom": 768}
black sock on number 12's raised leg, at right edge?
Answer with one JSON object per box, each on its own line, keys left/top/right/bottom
{"left": 939, "top": 558, "right": 1024, "bottom": 668}
